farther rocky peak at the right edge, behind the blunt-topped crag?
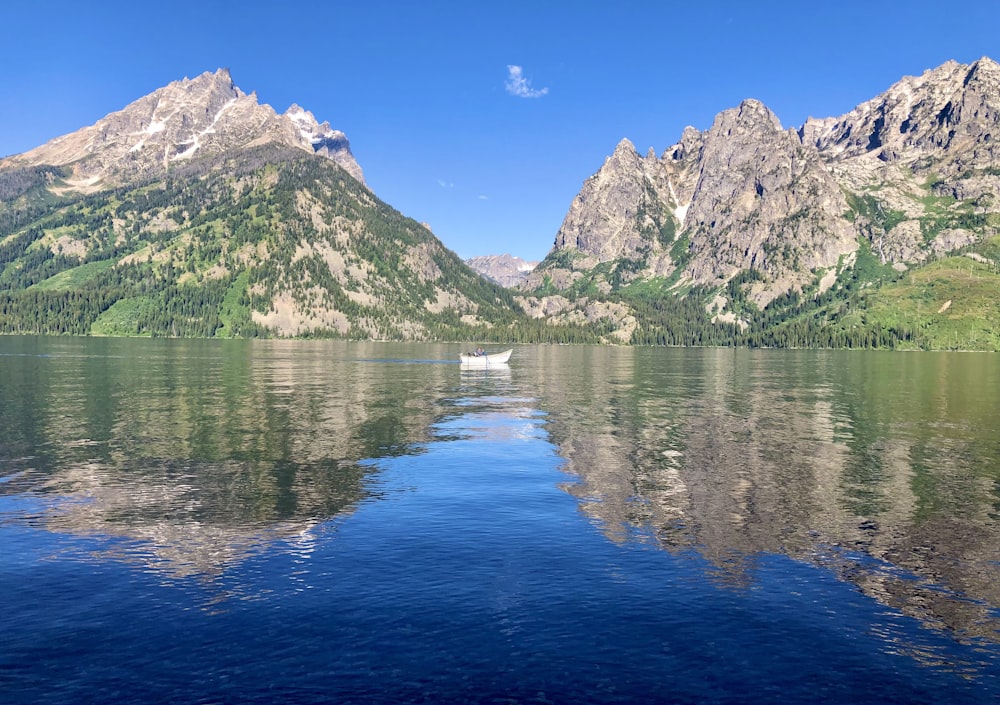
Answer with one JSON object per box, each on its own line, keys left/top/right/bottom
{"left": 799, "top": 57, "right": 1000, "bottom": 266}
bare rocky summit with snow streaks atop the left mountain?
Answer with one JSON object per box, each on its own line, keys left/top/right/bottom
{"left": 0, "top": 69, "right": 364, "bottom": 191}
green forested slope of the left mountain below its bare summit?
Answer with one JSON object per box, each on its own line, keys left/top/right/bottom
{"left": 0, "top": 147, "right": 587, "bottom": 340}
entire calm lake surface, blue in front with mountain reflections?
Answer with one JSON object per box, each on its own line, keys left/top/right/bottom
{"left": 0, "top": 337, "right": 1000, "bottom": 704}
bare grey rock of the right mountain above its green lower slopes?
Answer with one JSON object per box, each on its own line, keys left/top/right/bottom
{"left": 524, "top": 58, "right": 1000, "bottom": 306}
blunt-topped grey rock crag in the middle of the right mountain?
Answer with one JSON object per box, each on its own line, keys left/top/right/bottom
{"left": 684, "top": 100, "right": 857, "bottom": 302}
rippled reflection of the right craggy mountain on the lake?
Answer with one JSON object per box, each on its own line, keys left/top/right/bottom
{"left": 534, "top": 348, "right": 1000, "bottom": 641}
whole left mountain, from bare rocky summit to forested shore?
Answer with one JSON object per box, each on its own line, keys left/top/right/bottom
{"left": 0, "top": 69, "right": 564, "bottom": 340}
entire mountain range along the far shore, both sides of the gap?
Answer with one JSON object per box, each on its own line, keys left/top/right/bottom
{"left": 0, "top": 58, "right": 1000, "bottom": 349}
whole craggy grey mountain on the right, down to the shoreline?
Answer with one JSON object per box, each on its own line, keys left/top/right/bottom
{"left": 520, "top": 57, "right": 1000, "bottom": 345}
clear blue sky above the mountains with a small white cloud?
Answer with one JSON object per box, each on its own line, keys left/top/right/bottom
{"left": 0, "top": 0, "right": 1000, "bottom": 259}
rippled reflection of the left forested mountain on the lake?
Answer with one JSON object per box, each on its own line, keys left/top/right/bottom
{"left": 0, "top": 339, "right": 457, "bottom": 582}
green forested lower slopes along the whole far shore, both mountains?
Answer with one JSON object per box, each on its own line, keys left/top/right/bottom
{"left": 0, "top": 146, "right": 1000, "bottom": 350}
